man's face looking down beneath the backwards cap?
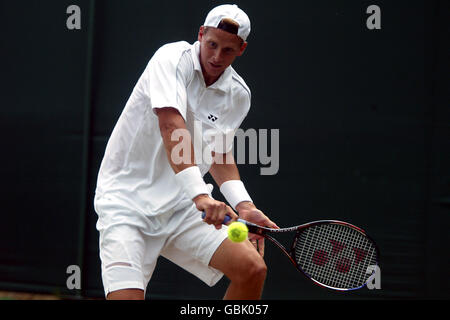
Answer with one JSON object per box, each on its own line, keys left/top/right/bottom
{"left": 198, "top": 26, "right": 247, "bottom": 85}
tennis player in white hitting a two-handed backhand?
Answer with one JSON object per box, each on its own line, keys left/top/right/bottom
{"left": 94, "top": 5, "right": 277, "bottom": 300}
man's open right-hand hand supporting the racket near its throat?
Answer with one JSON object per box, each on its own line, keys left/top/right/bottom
{"left": 236, "top": 201, "right": 279, "bottom": 257}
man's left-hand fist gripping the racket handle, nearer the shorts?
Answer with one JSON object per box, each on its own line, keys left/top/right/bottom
{"left": 192, "top": 194, "right": 238, "bottom": 229}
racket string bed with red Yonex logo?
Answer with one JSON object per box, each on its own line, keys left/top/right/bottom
{"left": 295, "top": 224, "right": 377, "bottom": 289}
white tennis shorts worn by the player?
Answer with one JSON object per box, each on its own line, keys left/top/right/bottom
{"left": 94, "top": 191, "right": 227, "bottom": 296}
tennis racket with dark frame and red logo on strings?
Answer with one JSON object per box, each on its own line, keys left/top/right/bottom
{"left": 204, "top": 216, "right": 379, "bottom": 291}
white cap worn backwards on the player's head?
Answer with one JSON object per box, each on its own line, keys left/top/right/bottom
{"left": 203, "top": 4, "right": 250, "bottom": 41}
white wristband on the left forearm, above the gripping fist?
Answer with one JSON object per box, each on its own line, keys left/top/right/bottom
{"left": 175, "top": 166, "right": 211, "bottom": 200}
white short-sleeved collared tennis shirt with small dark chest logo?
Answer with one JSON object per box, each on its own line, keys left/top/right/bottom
{"left": 96, "top": 41, "right": 251, "bottom": 216}
